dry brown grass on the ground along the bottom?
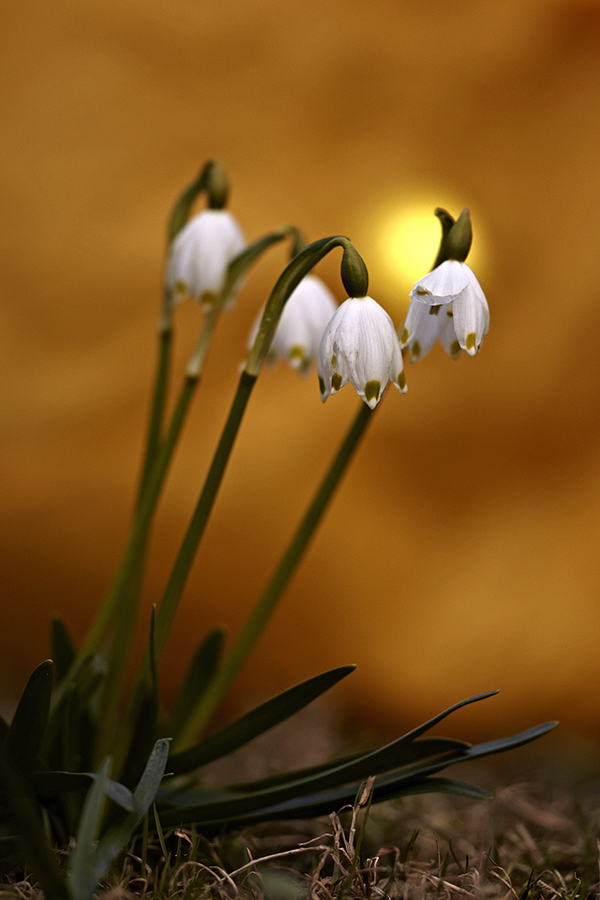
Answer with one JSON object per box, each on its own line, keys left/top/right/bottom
{"left": 0, "top": 769, "right": 600, "bottom": 900}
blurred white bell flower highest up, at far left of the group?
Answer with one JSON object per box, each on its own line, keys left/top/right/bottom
{"left": 166, "top": 209, "right": 246, "bottom": 304}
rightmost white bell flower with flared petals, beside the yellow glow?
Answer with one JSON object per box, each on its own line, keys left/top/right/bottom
{"left": 400, "top": 260, "right": 490, "bottom": 362}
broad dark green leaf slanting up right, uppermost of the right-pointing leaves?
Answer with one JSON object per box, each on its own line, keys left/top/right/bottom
{"left": 169, "top": 666, "right": 355, "bottom": 775}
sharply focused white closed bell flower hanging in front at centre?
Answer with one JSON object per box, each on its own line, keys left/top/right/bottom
{"left": 318, "top": 297, "right": 406, "bottom": 409}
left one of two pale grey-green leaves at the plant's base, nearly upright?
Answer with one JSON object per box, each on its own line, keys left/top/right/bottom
{"left": 67, "top": 756, "right": 112, "bottom": 900}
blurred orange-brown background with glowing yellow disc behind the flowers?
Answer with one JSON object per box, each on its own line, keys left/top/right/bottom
{"left": 0, "top": 0, "right": 600, "bottom": 738}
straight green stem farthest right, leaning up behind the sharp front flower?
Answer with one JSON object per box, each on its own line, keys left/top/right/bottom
{"left": 173, "top": 403, "right": 372, "bottom": 751}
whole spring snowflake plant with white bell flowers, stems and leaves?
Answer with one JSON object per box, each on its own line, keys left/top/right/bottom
{"left": 0, "top": 160, "right": 554, "bottom": 900}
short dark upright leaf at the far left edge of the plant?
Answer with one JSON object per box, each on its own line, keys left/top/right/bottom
{"left": 6, "top": 659, "right": 54, "bottom": 769}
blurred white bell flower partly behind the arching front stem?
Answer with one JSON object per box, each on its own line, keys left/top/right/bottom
{"left": 248, "top": 275, "right": 337, "bottom": 373}
